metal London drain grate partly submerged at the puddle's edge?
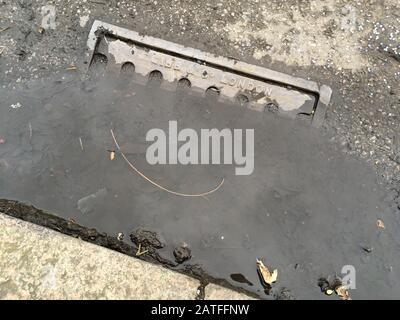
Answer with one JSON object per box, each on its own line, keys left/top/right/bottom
{"left": 87, "top": 21, "right": 332, "bottom": 126}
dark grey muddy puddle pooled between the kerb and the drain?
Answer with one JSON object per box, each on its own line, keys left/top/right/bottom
{"left": 0, "top": 75, "right": 400, "bottom": 299}
